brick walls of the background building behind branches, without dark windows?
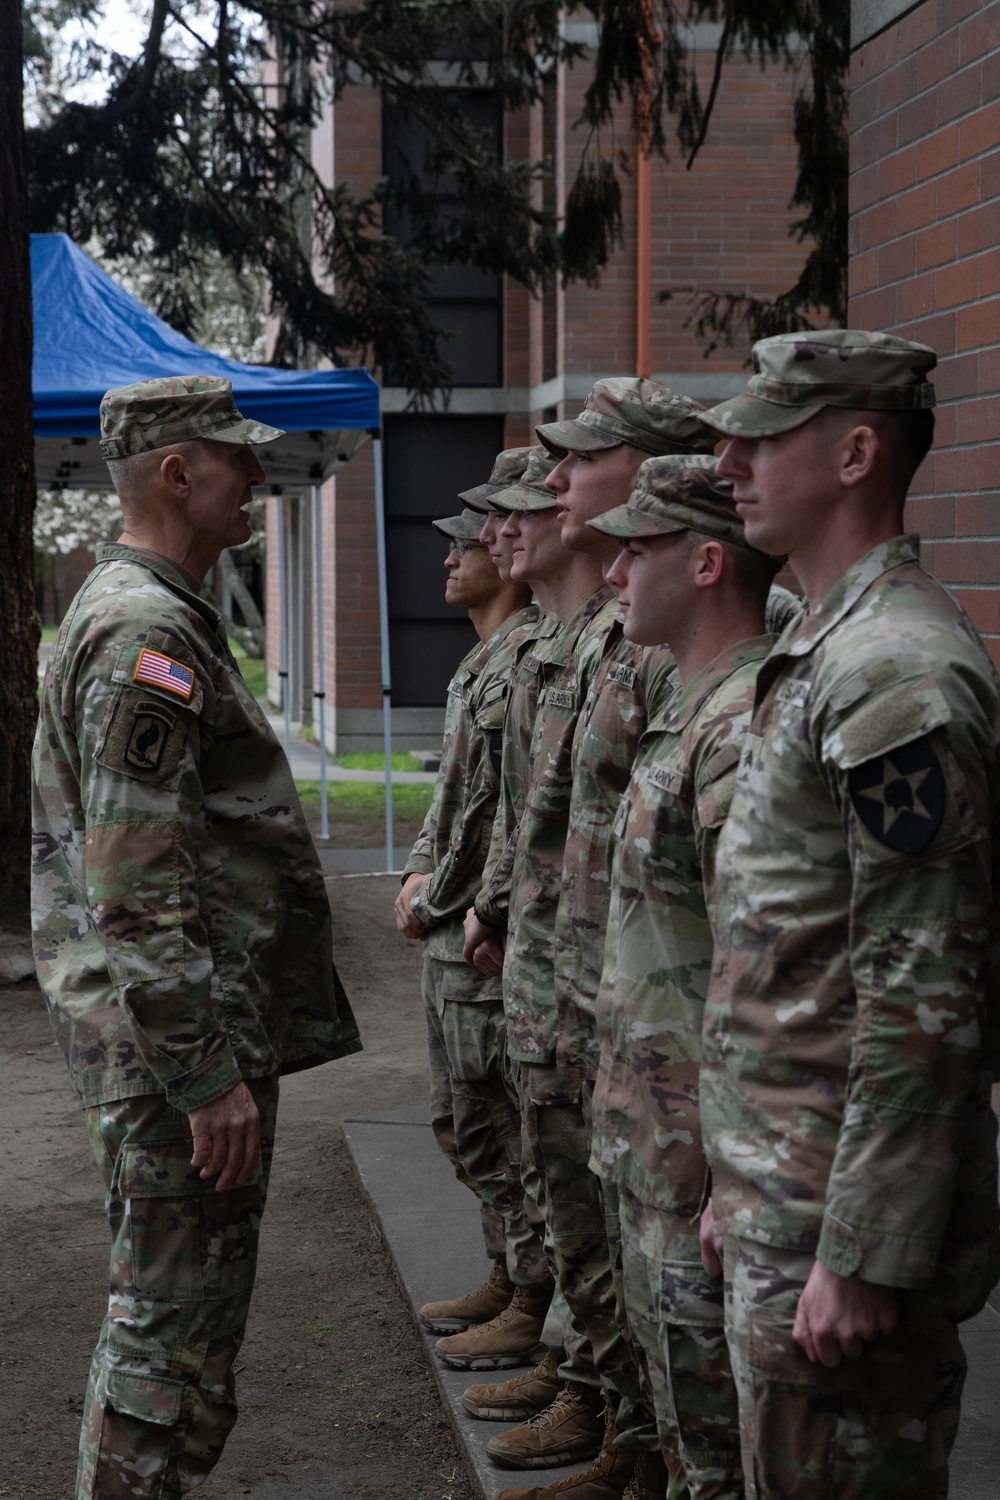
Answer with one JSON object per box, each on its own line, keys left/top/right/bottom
{"left": 268, "top": 29, "right": 807, "bottom": 726}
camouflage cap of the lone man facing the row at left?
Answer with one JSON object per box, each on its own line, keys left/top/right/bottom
{"left": 100, "top": 375, "right": 285, "bottom": 459}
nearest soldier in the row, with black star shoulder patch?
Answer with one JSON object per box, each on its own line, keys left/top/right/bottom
{"left": 702, "top": 329, "right": 1000, "bottom": 1500}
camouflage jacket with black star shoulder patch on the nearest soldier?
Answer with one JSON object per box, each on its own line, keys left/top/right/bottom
{"left": 702, "top": 537, "right": 1000, "bottom": 1287}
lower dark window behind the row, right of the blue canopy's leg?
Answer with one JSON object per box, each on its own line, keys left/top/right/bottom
{"left": 384, "top": 416, "right": 504, "bottom": 708}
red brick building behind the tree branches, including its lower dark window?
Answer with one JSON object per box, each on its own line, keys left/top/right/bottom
{"left": 267, "top": 21, "right": 805, "bottom": 750}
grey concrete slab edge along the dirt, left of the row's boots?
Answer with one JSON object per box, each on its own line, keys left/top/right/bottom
{"left": 343, "top": 1110, "right": 583, "bottom": 1500}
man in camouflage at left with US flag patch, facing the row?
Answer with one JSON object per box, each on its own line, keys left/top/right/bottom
{"left": 33, "top": 377, "right": 360, "bottom": 1500}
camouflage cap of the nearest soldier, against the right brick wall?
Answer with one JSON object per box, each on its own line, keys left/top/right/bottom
{"left": 699, "top": 329, "right": 937, "bottom": 438}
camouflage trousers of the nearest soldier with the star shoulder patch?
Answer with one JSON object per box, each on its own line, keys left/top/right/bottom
{"left": 726, "top": 1238, "right": 996, "bottom": 1500}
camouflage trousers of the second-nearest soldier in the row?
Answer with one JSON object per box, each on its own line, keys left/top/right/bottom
{"left": 618, "top": 1193, "right": 744, "bottom": 1500}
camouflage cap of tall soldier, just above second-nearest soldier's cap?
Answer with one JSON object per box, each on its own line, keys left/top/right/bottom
{"left": 535, "top": 375, "right": 715, "bottom": 458}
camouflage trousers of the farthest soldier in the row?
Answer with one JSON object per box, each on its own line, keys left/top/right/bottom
{"left": 423, "top": 954, "right": 552, "bottom": 1286}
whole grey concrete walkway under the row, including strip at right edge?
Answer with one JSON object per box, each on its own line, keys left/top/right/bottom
{"left": 343, "top": 1110, "right": 1000, "bottom": 1500}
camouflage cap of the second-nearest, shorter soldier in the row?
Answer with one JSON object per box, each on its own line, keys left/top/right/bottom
{"left": 588, "top": 455, "right": 754, "bottom": 551}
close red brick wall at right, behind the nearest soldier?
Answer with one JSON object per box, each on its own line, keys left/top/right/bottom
{"left": 850, "top": 0, "right": 1000, "bottom": 666}
